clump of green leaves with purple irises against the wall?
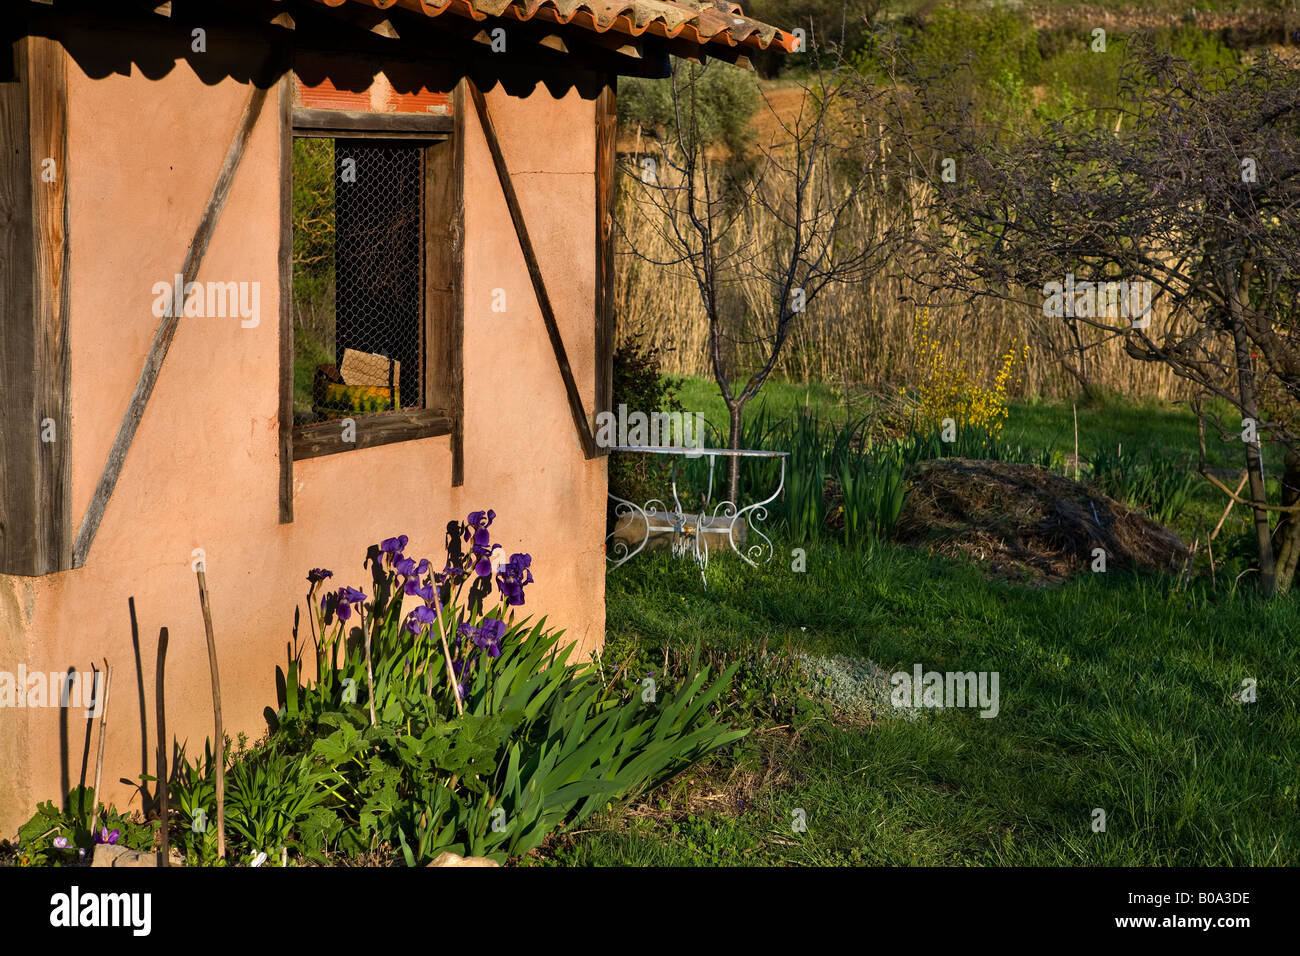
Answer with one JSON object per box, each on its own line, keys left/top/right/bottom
{"left": 170, "top": 511, "right": 748, "bottom": 866}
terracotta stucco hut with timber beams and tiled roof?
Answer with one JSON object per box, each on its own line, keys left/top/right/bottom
{"left": 0, "top": 0, "right": 797, "bottom": 834}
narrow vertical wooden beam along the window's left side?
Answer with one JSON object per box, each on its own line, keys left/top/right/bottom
{"left": 276, "top": 62, "right": 294, "bottom": 524}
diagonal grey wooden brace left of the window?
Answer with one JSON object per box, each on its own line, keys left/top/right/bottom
{"left": 73, "top": 76, "right": 268, "bottom": 567}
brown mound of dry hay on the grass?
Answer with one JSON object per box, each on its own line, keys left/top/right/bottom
{"left": 894, "top": 458, "right": 1187, "bottom": 584}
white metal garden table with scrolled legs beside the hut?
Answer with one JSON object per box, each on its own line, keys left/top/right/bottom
{"left": 605, "top": 445, "right": 790, "bottom": 588}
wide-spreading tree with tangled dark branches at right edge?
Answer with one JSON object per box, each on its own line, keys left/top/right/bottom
{"left": 894, "top": 43, "right": 1300, "bottom": 594}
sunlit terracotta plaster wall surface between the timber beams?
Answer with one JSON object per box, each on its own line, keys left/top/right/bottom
{"left": 0, "top": 42, "right": 606, "bottom": 835}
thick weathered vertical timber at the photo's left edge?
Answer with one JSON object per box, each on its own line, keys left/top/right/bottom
{"left": 0, "top": 36, "right": 72, "bottom": 575}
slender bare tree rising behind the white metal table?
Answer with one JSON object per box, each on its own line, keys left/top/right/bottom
{"left": 631, "top": 53, "right": 909, "bottom": 501}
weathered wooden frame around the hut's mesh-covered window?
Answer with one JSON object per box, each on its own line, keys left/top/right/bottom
{"left": 280, "top": 72, "right": 464, "bottom": 523}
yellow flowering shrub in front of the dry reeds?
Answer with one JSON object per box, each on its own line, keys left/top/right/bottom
{"left": 911, "top": 306, "right": 1028, "bottom": 438}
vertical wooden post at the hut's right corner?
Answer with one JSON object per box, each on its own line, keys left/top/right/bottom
{"left": 595, "top": 74, "right": 618, "bottom": 454}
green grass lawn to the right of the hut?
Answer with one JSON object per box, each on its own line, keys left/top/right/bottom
{"left": 530, "top": 386, "right": 1300, "bottom": 866}
